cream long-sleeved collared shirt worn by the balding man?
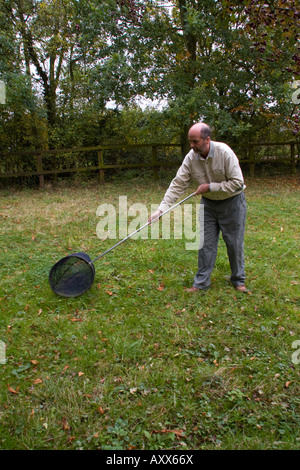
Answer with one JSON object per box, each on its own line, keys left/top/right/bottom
{"left": 159, "top": 141, "right": 246, "bottom": 212}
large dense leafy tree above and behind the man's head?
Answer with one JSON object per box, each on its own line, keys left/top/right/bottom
{"left": 99, "top": 0, "right": 299, "bottom": 140}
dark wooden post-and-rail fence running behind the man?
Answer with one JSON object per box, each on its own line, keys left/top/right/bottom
{"left": 0, "top": 141, "right": 300, "bottom": 188}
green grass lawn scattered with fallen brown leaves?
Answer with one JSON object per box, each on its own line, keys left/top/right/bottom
{"left": 0, "top": 172, "right": 300, "bottom": 450}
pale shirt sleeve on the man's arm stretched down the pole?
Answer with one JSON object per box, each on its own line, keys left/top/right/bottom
{"left": 159, "top": 156, "right": 191, "bottom": 212}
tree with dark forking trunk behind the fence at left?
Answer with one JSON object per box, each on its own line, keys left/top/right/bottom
{"left": 0, "top": 0, "right": 139, "bottom": 149}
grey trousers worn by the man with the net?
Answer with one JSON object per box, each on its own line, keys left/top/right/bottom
{"left": 193, "top": 192, "right": 247, "bottom": 289}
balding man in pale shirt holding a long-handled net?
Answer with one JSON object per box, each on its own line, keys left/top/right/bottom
{"left": 149, "top": 123, "right": 247, "bottom": 292}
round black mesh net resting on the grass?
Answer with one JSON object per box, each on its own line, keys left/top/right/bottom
{"left": 49, "top": 253, "right": 95, "bottom": 297}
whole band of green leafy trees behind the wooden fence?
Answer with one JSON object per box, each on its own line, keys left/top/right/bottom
{"left": 0, "top": 0, "right": 299, "bottom": 154}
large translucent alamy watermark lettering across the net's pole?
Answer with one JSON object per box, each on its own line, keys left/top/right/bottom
{"left": 96, "top": 196, "right": 204, "bottom": 250}
